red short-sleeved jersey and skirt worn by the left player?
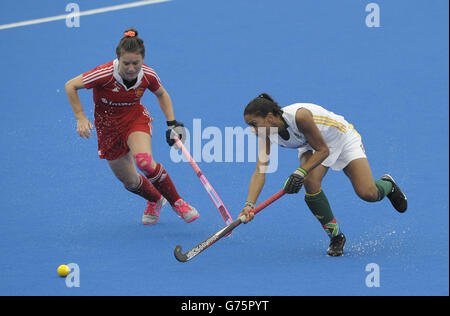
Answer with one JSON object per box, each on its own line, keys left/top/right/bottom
{"left": 82, "top": 59, "right": 161, "bottom": 160}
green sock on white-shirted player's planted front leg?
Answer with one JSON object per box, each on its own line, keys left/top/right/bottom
{"left": 305, "top": 190, "right": 341, "bottom": 238}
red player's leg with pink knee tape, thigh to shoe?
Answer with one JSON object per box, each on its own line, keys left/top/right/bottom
{"left": 127, "top": 131, "right": 199, "bottom": 223}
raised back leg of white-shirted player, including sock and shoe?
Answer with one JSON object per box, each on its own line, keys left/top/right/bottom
{"left": 344, "top": 158, "right": 407, "bottom": 212}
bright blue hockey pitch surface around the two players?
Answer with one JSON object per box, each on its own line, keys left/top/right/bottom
{"left": 0, "top": 0, "right": 449, "bottom": 295}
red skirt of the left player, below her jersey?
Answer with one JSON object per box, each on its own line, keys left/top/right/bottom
{"left": 95, "top": 105, "right": 153, "bottom": 160}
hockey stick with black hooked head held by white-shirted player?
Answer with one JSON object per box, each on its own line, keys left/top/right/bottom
{"left": 174, "top": 190, "right": 285, "bottom": 262}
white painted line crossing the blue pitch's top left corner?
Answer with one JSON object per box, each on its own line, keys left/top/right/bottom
{"left": 0, "top": 0, "right": 172, "bottom": 30}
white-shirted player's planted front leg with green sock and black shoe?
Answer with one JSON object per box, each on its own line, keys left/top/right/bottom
{"left": 300, "top": 151, "right": 345, "bottom": 256}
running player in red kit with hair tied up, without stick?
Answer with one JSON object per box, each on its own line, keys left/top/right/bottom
{"left": 66, "top": 29, "right": 199, "bottom": 225}
